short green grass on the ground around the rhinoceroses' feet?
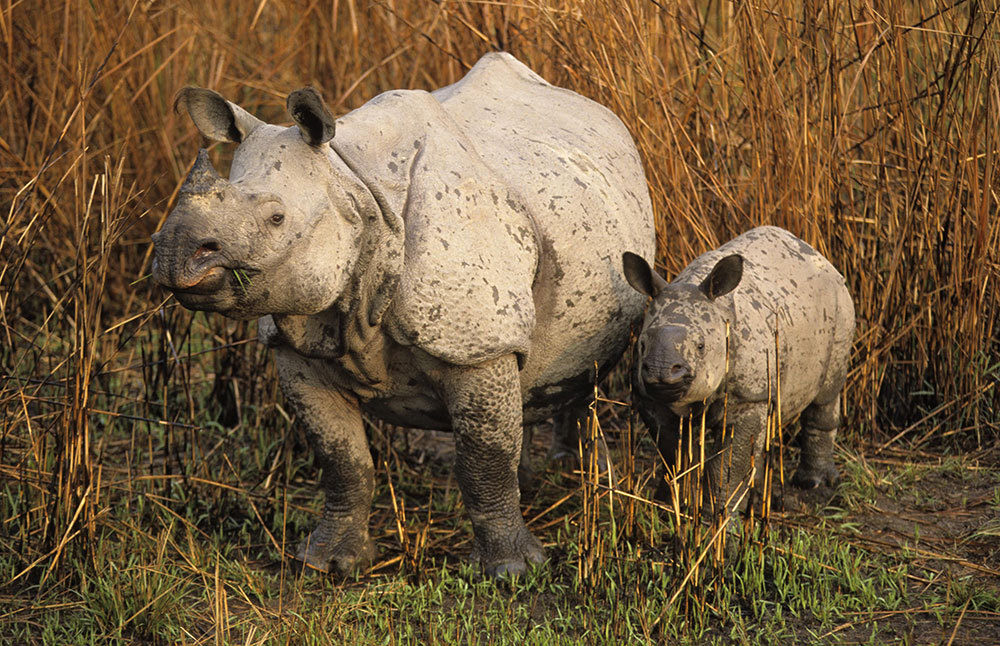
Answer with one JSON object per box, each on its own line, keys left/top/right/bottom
{"left": 0, "top": 416, "right": 1000, "bottom": 644}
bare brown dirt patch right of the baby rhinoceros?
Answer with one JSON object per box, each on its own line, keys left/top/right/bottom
{"left": 783, "top": 456, "right": 1000, "bottom": 644}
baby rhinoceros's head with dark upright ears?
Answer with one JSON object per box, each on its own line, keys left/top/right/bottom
{"left": 622, "top": 252, "right": 743, "bottom": 409}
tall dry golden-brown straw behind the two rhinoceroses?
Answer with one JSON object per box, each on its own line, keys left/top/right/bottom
{"left": 0, "top": 0, "right": 1000, "bottom": 600}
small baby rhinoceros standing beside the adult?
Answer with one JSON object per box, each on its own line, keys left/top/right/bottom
{"left": 623, "top": 226, "right": 854, "bottom": 512}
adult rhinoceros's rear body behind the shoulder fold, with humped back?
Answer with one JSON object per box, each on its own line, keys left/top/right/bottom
{"left": 433, "top": 54, "right": 655, "bottom": 410}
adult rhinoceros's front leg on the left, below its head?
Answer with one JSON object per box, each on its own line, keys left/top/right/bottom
{"left": 275, "top": 348, "right": 375, "bottom": 576}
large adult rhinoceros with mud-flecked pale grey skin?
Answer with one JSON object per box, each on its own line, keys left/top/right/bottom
{"left": 153, "top": 54, "right": 654, "bottom": 575}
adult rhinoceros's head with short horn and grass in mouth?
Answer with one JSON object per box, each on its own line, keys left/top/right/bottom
{"left": 153, "top": 88, "right": 377, "bottom": 318}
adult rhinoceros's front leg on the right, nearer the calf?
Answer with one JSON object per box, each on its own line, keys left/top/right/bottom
{"left": 440, "top": 355, "right": 545, "bottom": 576}
